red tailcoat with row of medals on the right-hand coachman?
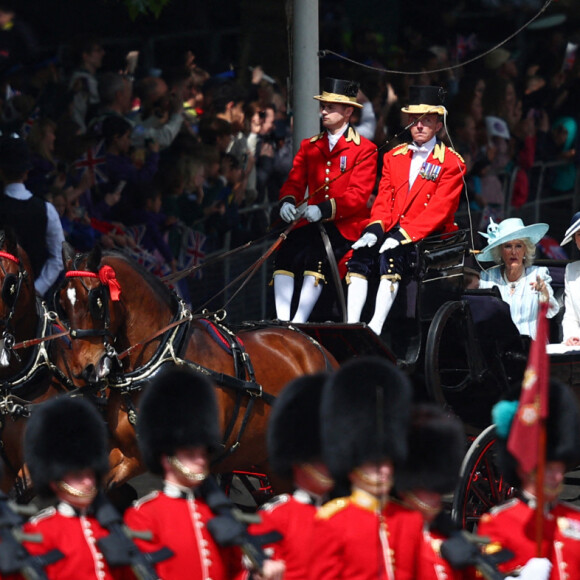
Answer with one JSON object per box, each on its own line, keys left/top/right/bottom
{"left": 369, "top": 141, "right": 465, "bottom": 243}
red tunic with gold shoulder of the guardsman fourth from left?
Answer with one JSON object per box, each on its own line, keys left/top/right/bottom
{"left": 308, "top": 490, "right": 424, "bottom": 580}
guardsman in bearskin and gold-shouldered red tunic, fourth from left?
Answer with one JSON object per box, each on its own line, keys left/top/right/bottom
{"left": 308, "top": 357, "right": 423, "bottom": 580}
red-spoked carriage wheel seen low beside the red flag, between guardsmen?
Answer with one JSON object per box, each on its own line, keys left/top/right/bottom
{"left": 451, "top": 425, "right": 515, "bottom": 531}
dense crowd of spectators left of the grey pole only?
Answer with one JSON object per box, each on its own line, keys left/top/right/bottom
{"left": 0, "top": 3, "right": 292, "bottom": 294}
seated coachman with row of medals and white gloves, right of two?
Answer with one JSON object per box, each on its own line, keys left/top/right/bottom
{"left": 347, "top": 86, "right": 465, "bottom": 335}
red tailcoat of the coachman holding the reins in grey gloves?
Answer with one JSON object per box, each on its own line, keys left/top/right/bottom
{"left": 280, "top": 127, "right": 377, "bottom": 241}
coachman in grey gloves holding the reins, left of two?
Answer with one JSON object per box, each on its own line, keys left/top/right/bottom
{"left": 274, "top": 78, "right": 377, "bottom": 322}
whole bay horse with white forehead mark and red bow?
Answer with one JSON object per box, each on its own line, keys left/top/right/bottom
{"left": 57, "top": 246, "right": 338, "bottom": 486}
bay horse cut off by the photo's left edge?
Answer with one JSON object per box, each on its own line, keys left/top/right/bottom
{"left": 0, "top": 230, "right": 72, "bottom": 499}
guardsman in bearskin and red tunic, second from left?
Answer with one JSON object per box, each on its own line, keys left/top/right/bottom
{"left": 125, "top": 367, "right": 284, "bottom": 580}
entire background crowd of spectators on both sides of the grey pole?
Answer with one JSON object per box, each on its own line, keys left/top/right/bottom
{"left": 0, "top": 6, "right": 580, "bottom": 300}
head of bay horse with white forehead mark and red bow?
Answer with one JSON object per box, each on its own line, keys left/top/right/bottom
{"left": 56, "top": 244, "right": 124, "bottom": 383}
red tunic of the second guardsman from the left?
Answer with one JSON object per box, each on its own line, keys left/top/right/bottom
{"left": 125, "top": 486, "right": 244, "bottom": 580}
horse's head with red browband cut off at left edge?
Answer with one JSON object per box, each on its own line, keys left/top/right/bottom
{"left": 0, "top": 229, "right": 37, "bottom": 367}
